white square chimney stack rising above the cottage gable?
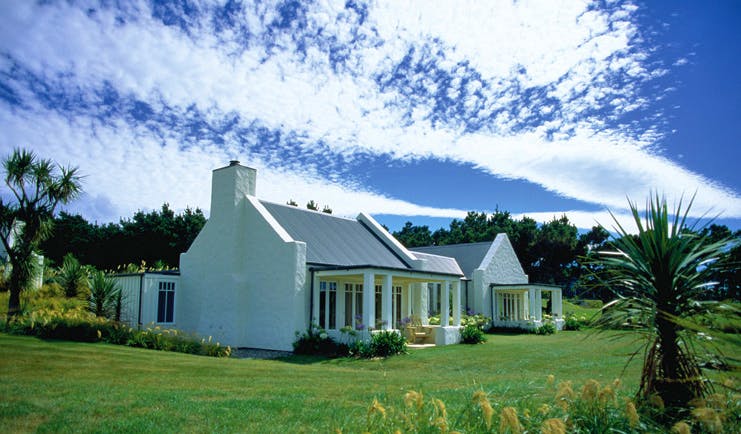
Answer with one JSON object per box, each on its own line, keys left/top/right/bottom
{"left": 209, "top": 160, "right": 257, "bottom": 219}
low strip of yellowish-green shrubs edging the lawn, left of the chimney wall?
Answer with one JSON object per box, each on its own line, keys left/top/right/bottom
{"left": 0, "top": 309, "right": 231, "bottom": 357}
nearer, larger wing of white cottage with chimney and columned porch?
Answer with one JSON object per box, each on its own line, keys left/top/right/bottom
{"left": 175, "top": 161, "right": 472, "bottom": 350}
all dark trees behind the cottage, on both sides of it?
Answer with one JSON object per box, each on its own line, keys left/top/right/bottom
{"left": 41, "top": 204, "right": 741, "bottom": 300}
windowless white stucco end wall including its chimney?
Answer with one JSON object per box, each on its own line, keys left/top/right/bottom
{"left": 175, "top": 165, "right": 308, "bottom": 350}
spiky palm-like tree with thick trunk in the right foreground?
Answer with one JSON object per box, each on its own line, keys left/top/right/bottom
{"left": 593, "top": 195, "right": 731, "bottom": 408}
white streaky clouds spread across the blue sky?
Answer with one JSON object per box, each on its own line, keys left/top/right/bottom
{"left": 0, "top": 1, "right": 741, "bottom": 225}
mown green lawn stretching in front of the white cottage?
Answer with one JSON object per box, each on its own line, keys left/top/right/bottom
{"left": 0, "top": 332, "right": 639, "bottom": 432}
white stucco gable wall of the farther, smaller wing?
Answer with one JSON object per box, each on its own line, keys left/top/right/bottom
{"left": 469, "top": 234, "right": 528, "bottom": 318}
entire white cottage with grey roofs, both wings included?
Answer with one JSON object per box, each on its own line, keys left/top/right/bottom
{"left": 118, "top": 161, "right": 560, "bottom": 350}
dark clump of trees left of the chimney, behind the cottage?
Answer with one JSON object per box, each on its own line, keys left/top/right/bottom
{"left": 40, "top": 204, "right": 206, "bottom": 270}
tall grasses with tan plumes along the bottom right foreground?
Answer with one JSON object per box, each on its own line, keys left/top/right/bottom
{"left": 362, "top": 375, "right": 741, "bottom": 434}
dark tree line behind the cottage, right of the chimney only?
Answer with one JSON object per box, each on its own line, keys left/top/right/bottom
{"left": 393, "top": 210, "right": 741, "bottom": 300}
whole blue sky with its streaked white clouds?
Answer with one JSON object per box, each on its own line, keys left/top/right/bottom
{"left": 0, "top": 0, "right": 741, "bottom": 234}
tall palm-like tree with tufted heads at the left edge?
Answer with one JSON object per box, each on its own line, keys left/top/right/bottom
{"left": 0, "top": 149, "right": 81, "bottom": 319}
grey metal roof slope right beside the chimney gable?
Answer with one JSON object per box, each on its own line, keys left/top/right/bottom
{"left": 260, "top": 200, "right": 409, "bottom": 269}
